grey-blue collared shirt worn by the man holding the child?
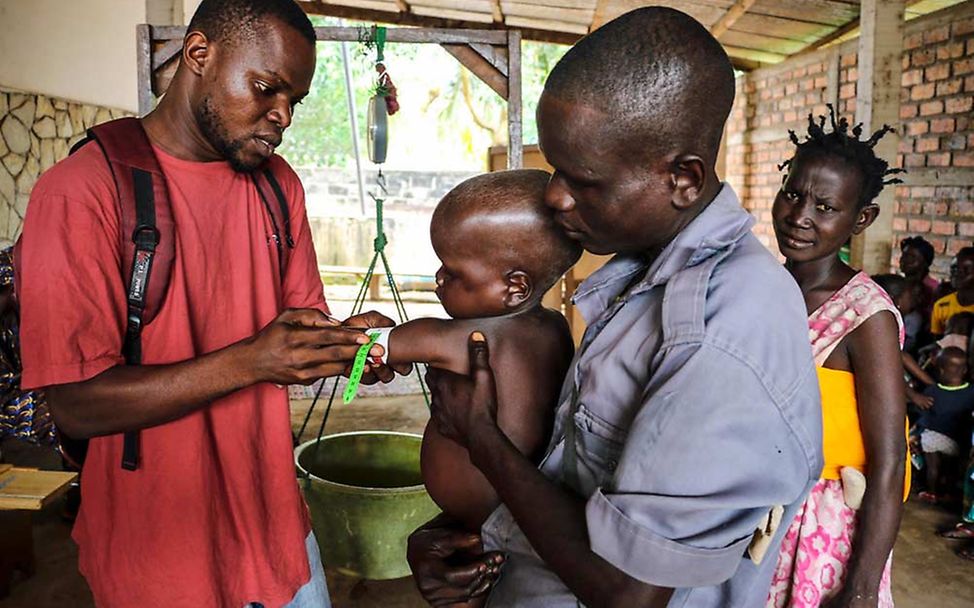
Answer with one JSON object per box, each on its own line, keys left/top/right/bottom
{"left": 483, "top": 185, "right": 822, "bottom": 608}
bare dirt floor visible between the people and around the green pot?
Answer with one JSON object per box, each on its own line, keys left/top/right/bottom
{"left": 0, "top": 396, "right": 974, "bottom": 608}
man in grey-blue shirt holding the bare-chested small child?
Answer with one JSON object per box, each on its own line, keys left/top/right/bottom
{"left": 410, "top": 7, "right": 822, "bottom": 607}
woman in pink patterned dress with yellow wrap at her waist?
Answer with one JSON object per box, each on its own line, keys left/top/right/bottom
{"left": 768, "top": 106, "right": 907, "bottom": 608}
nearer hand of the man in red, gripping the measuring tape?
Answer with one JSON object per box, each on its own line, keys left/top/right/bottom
{"left": 244, "top": 308, "right": 381, "bottom": 384}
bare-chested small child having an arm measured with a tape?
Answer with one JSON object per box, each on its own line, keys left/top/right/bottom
{"left": 376, "top": 170, "right": 581, "bottom": 531}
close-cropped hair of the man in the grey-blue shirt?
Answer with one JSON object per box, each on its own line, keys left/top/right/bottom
{"left": 544, "top": 6, "right": 735, "bottom": 161}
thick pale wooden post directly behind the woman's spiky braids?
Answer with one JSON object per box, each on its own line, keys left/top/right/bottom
{"left": 851, "top": 0, "right": 905, "bottom": 274}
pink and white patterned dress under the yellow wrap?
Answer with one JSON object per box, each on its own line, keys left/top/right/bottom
{"left": 767, "top": 272, "right": 904, "bottom": 608}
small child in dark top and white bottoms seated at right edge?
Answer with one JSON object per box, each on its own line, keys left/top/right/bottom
{"left": 918, "top": 346, "right": 974, "bottom": 504}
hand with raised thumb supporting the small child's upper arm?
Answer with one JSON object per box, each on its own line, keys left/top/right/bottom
{"left": 426, "top": 331, "right": 497, "bottom": 447}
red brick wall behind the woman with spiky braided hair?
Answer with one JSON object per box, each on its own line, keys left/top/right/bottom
{"left": 727, "top": 3, "right": 974, "bottom": 278}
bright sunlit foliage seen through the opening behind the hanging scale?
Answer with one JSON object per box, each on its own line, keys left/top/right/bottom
{"left": 280, "top": 17, "right": 568, "bottom": 170}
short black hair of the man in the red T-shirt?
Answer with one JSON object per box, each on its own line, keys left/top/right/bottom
{"left": 186, "top": 0, "right": 315, "bottom": 44}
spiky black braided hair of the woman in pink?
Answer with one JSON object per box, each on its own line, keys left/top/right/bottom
{"left": 778, "top": 104, "right": 905, "bottom": 208}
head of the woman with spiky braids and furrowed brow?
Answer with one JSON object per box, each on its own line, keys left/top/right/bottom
{"left": 771, "top": 105, "right": 902, "bottom": 262}
